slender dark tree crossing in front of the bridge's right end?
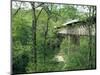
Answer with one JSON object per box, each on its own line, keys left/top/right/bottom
{"left": 87, "top": 6, "right": 96, "bottom": 68}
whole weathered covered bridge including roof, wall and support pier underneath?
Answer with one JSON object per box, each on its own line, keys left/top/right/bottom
{"left": 55, "top": 16, "right": 96, "bottom": 45}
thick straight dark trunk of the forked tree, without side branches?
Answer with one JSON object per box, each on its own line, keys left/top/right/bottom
{"left": 31, "top": 2, "right": 37, "bottom": 71}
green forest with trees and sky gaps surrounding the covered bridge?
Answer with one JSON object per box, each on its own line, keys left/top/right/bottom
{"left": 12, "top": 1, "right": 96, "bottom": 74}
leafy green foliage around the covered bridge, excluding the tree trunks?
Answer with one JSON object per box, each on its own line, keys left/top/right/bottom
{"left": 12, "top": 4, "right": 96, "bottom": 73}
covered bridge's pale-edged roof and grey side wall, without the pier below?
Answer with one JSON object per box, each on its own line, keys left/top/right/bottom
{"left": 56, "top": 18, "right": 96, "bottom": 36}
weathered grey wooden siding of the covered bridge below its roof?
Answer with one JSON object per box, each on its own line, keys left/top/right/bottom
{"left": 57, "top": 25, "right": 95, "bottom": 35}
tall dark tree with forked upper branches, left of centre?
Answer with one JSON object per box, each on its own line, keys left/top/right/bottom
{"left": 30, "top": 2, "right": 42, "bottom": 71}
